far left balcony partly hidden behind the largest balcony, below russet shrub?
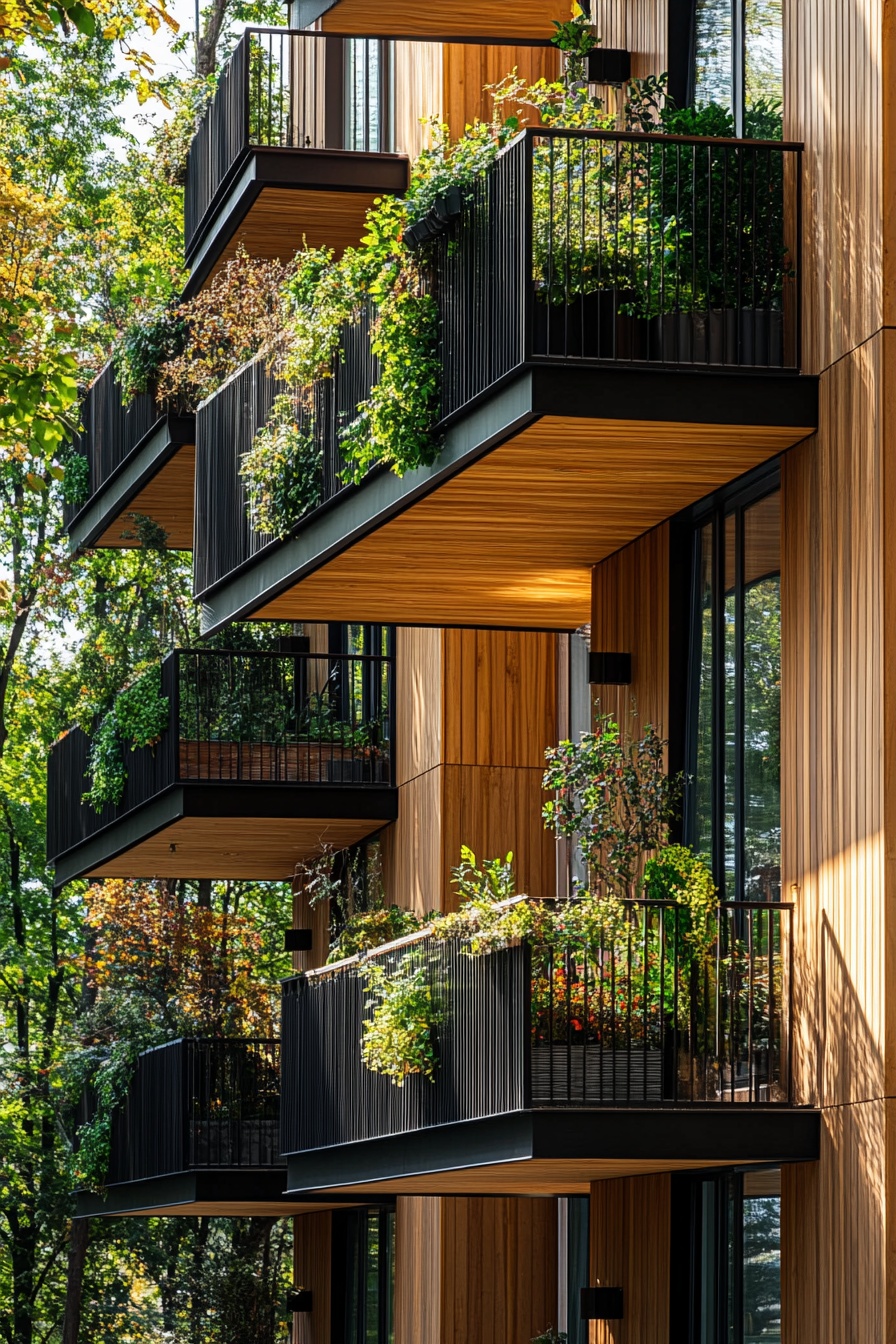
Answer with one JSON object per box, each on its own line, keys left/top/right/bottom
{"left": 64, "top": 364, "right": 196, "bottom": 551}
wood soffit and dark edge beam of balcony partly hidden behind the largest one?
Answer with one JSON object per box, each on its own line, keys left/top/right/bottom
{"left": 69, "top": 415, "right": 196, "bottom": 551}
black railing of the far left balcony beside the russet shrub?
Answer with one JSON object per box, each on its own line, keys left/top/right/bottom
{"left": 63, "top": 363, "right": 165, "bottom": 527}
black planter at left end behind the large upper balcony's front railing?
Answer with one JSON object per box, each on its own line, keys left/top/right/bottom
{"left": 532, "top": 289, "right": 647, "bottom": 359}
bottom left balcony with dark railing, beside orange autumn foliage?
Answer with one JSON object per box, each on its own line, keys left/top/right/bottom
{"left": 77, "top": 1039, "right": 308, "bottom": 1218}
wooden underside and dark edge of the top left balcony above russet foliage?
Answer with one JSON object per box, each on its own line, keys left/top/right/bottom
{"left": 184, "top": 148, "right": 408, "bottom": 297}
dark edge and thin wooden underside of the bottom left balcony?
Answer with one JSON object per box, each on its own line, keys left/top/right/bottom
{"left": 75, "top": 1167, "right": 360, "bottom": 1218}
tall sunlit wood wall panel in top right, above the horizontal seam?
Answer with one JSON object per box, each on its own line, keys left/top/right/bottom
{"left": 783, "top": 0, "right": 881, "bottom": 372}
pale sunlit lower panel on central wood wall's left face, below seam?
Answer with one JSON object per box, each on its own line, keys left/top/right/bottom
{"left": 382, "top": 769, "right": 443, "bottom": 914}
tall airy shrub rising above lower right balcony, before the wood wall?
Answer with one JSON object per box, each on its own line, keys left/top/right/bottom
{"left": 543, "top": 714, "right": 684, "bottom": 899}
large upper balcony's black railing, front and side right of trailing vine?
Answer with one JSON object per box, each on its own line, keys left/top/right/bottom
{"left": 435, "top": 128, "right": 802, "bottom": 417}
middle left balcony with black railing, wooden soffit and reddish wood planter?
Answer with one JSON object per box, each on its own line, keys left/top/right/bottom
{"left": 47, "top": 649, "right": 398, "bottom": 886}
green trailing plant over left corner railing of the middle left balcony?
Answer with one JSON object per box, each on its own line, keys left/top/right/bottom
{"left": 82, "top": 667, "right": 168, "bottom": 812}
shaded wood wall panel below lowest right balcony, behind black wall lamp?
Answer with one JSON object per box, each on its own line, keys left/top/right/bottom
{"left": 588, "top": 1175, "right": 671, "bottom": 1344}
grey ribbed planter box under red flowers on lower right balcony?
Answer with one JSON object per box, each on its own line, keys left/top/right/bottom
{"left": 532, "top": 1044, "right": 664, "bottom": 1106}
